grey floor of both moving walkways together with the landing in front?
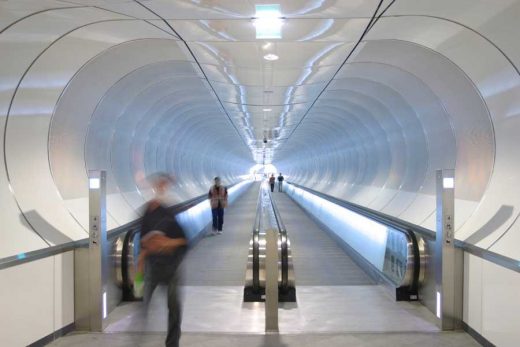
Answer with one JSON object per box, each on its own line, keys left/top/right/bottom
{"left": 47, "top": 186, "right": 478, "bottom": 347}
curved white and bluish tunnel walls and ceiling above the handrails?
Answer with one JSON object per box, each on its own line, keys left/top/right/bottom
{"left": 0, "top": 0, "right": 520, "bottom": 264}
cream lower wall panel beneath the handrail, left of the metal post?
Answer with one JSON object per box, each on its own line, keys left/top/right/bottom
{"left": 0, "top": 252, "right": 74, "bottom": 347}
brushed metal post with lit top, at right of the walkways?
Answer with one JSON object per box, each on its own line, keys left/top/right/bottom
{"left": 435, "top": 170, "right": 464, "bottom": 330}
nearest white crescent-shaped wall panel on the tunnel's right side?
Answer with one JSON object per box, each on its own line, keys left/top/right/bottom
{"left": 371, "top": 18, "right": 520, "bottom": 256}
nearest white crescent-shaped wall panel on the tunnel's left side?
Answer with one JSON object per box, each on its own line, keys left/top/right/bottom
{"left": 6, "top": 22, "right": 176, "bottom": 244}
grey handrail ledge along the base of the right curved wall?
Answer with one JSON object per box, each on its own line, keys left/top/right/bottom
{"left": 287, "top": 182, "right": 520, "bottom": 273}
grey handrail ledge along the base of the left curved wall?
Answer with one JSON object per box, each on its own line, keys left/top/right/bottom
{"left": 0, "top": 182, "right": 244, "bottom": 270}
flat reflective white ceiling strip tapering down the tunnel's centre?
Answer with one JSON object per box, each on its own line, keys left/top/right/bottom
{"left": 50, "top": 0, "right": 390, "bottom": 163}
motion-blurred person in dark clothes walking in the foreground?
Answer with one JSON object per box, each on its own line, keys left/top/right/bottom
{"left": 139, "top": 173, "right": 187, "bottom": 347}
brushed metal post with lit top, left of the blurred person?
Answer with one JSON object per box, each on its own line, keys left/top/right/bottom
{"left": 74, "top": 170, "right": 108, "bottom": 332}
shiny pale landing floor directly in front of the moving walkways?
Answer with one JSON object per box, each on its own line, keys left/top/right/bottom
{"left": 106, "top": 285, "right": 438, "bottom": 334}
